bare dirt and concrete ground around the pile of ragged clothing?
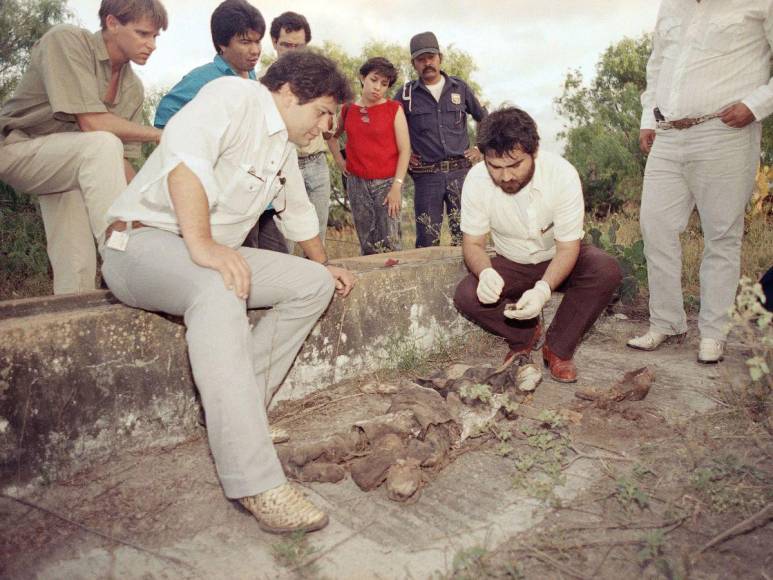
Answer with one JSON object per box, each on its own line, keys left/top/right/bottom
{"left": 0, "top": 317, "right": 773, "bottom": 580}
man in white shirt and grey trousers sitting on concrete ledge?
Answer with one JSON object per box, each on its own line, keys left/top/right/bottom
{"left": 103, "top": 51, "right": 354, "bottom": 533}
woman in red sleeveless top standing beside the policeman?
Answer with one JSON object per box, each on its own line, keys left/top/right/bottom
{"left": 328, "top": 57, "right": 411, "bottom": 255}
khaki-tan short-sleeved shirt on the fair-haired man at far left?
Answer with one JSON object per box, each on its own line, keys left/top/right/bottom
{"left": 0, "top": 24, "right": 144, "bottom": 158}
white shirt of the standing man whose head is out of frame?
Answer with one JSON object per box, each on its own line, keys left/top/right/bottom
{"left": 641, "top": 0, "right": 773, "bottom": 129}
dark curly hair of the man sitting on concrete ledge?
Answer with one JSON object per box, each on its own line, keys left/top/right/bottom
{"left": 260, "top": 50, "right": 352, "bottom": 105}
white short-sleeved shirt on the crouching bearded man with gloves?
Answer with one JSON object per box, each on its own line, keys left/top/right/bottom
{"left": 461, "top": 151, "right": 585, "bottom": 264}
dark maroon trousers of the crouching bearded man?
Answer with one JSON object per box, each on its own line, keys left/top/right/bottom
{"left": 454, "top": 244, "right": 622, "bottom": 359}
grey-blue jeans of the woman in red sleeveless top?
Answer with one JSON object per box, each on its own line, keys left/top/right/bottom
{"left": 346, "top": 175, "right": 402, "bottom": 256}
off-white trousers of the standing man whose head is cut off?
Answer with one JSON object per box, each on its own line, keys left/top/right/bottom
{"left": 640, "top": 119, "right": 761, "bottom": 340}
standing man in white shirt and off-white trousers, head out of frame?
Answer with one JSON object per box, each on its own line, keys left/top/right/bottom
{"left": 628, "top": 0, "right": 773, "bottom": 363}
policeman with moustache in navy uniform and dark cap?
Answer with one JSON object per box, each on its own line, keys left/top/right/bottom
{"left": 395, "top": 32, "right": 487, "bottom": 248}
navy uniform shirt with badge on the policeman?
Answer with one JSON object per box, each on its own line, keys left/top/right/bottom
{"left": 394, "top": 73, "right": 487, "bottom": 163}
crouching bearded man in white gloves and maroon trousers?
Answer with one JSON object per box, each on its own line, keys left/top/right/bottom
{"left": 454, "top": 108, "right": 621, "bottom": 390}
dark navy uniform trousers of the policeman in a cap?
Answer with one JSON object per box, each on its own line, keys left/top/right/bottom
{"left": 411, "top": 169, "right": 469, "bottom": 248}
